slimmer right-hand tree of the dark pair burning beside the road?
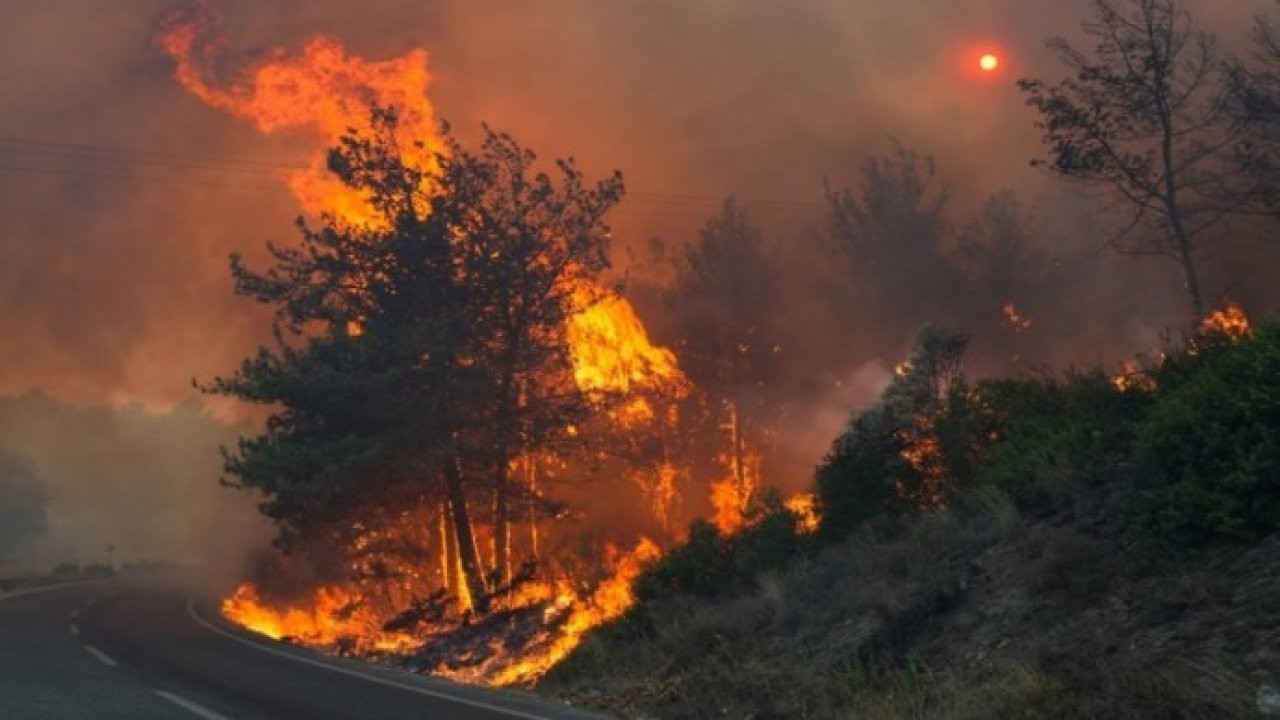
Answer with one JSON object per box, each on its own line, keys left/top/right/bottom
{"left": 445, "top": 132, "right": 622, "bottom": 584}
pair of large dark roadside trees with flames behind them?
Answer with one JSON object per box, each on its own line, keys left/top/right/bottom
{"left": 206, "top": 110, "right": 622, "bottom": 610}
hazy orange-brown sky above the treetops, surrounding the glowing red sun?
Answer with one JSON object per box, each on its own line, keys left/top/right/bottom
{"left": 0, "top": 0, "right": 1271, "bottom": 405}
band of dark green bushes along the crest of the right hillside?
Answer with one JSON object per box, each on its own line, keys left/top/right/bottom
{"left": 815, "top": 311, "right": 1280, "bottom": 548}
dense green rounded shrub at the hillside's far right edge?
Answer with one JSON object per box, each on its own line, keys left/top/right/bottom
{"left": 1129, "top": 322, "right": 1280, "bottom": 548}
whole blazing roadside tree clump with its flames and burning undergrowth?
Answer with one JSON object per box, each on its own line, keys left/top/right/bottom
{"left": 160, "top": 5, "right": 817, "bottom": 685}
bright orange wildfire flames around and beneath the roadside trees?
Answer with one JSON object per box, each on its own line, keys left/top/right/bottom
{"left": 160, "top": 11, "right": 817, "bottom": 685}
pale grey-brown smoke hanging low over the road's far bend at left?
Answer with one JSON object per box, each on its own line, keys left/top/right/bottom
{"left": 0, "top": 395, "right": 269, "bottom": 577}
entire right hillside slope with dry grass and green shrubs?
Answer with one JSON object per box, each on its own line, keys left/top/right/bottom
{"left": 540, "top": 315, "right": 1280, "bottom": 719}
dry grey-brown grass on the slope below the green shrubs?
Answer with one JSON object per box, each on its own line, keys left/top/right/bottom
{"left": 540, "top": 491, "right": 1256, "bottom": 720}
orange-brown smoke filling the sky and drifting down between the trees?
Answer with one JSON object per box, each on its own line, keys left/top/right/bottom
{"left": 0, "top": 0, "right": 1274, "bottom": 527}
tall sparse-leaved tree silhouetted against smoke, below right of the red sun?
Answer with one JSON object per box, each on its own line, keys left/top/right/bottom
{"left": 1019, "top": 0, "right": 1235, "bottom": 322}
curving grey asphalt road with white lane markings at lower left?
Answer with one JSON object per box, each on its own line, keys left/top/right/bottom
{"left": 0, "top": 582, "right": 600, "bottom": 720}
